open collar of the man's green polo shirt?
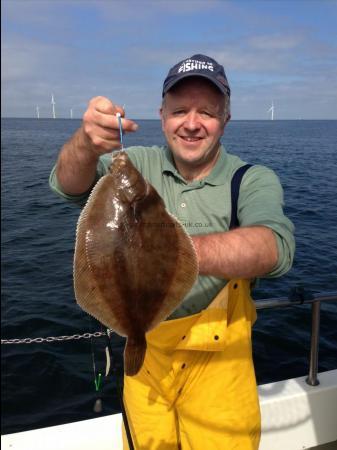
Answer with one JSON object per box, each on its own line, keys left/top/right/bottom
{"left": 162, "top": 145, "right": 228, "bottom": 186}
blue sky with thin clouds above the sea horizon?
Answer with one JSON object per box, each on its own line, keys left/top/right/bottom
{"left": 1, "top": 0, "right": 337, "bottom": 120}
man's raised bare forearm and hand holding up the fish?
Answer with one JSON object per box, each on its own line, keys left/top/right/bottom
{"left": 56, "top": 97, "right": 138, "bottom": 195}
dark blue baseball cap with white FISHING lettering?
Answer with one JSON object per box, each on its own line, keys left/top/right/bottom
{"left": 163, "top": 55, "right": 231, "bottom": 97}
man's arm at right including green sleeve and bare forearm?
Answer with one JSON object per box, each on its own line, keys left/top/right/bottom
{"left": 192, "top": 165, "right": 295, "bottom": 279}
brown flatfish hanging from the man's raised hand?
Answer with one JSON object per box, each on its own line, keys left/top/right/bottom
{"left": 74, "top": 151, "right": 198, "bottom": 376}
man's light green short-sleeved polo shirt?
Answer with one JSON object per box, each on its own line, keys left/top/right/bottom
{"left": 49, "top": 146, "right": 295, "bottom": 318}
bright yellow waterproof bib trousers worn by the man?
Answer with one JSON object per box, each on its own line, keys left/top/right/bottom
{"left": 123, "top": 280, "right": 260, "bottom": 450}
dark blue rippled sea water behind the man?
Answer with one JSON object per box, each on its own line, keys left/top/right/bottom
{"left": 1, "top": 119, "right": 337, "bottom": 433}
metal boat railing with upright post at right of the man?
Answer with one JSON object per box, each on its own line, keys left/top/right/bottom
{"left": 255, "top": 286, "right": 337, "bottom": 386}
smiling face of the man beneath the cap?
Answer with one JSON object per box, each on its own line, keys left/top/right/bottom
{"left": 160, "top": 77, "right": 227, "bottom": 176}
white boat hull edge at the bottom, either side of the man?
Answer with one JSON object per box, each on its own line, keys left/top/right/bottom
{"left": 1, "top": 370, "right": 337, "bottom": 450}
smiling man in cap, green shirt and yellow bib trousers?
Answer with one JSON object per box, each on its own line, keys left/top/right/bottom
{"left": 50, "top": 55, "right": 295, "bottom": 450}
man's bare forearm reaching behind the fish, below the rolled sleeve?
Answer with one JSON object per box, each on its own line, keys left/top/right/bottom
{"left": 192, "top": 226, "right": 278, "bottom": 280}
